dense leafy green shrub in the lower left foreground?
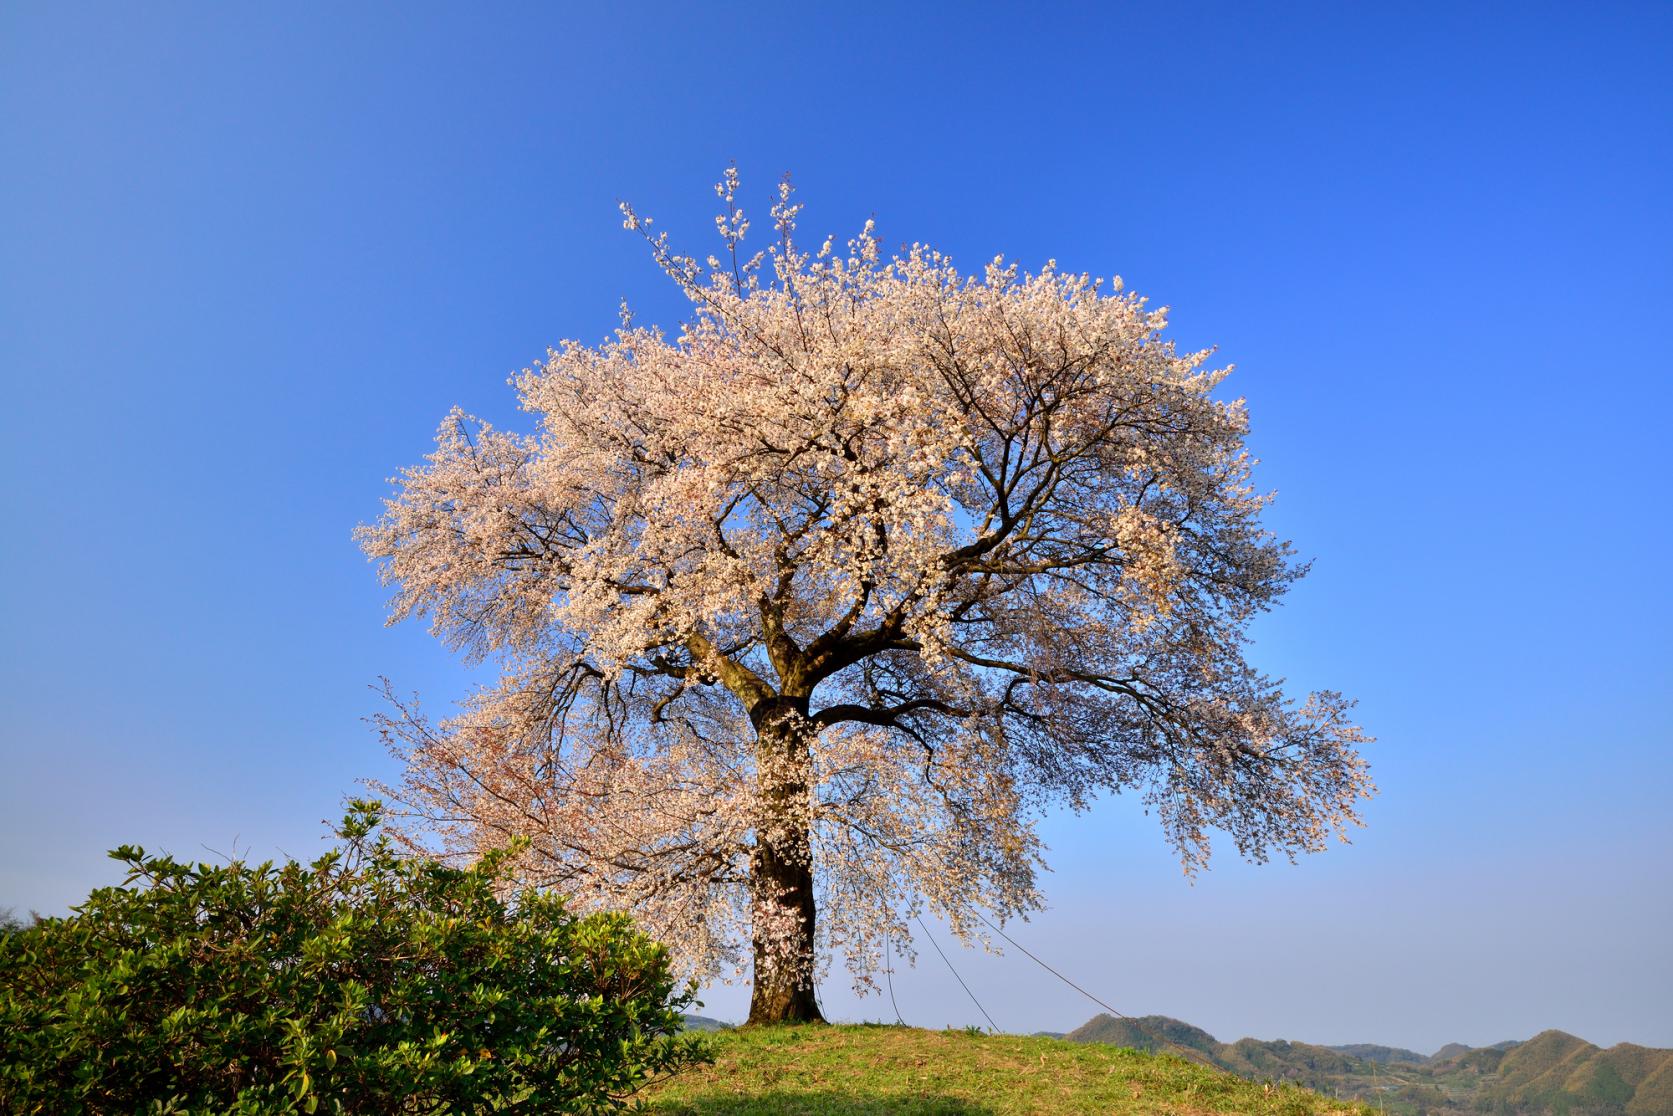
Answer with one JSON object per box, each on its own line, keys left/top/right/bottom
{"left": 0, "top": 801, "right": 704, "bottom": 1113}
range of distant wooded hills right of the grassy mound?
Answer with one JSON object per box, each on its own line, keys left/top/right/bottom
{"left": 1066, "top": 1016, "right": 1673, "bottom": 1116}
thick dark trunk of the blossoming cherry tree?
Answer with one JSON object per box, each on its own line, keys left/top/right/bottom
{"left": 750, "top": 701, "right": 825, "bottom": 1024}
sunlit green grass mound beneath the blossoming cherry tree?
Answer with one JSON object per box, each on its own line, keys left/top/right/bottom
{"left": 641, "top": 1026, "right": 1374, "bottom": 1116}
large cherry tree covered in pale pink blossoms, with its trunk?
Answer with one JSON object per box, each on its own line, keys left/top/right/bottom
{"left": 358, "top": 172, "right": 1372, "bottom": 1022}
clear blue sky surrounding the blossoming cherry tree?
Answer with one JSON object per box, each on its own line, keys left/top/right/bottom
{"left": 0, "top": 3, "right": 1673, "bottom": 1051}
